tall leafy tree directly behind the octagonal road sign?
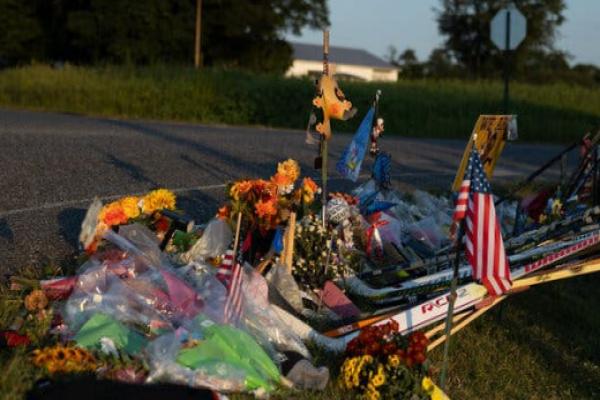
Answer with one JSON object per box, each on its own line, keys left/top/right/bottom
{"left": 437, "top": 0, "right": 565, "bottom": 76}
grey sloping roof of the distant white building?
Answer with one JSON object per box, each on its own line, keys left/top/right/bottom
{"left": 290, "top": 42, "right": 396, "bottom": 69}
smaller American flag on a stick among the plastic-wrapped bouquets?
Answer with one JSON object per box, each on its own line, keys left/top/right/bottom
{"left": 217, "top": 250, "right": 244, "bottom": 323}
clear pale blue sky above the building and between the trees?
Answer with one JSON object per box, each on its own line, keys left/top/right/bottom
{"left": 287, "top": 0, "right": 600, "bottom": 66}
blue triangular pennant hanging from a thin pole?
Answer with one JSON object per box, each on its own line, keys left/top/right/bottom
{"left": 335, "top": 107, "right": 375, "bottom": 182}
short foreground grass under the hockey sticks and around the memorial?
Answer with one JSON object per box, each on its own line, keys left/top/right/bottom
{"left": 0, "top": 275, "right": 600, "bottom": 400}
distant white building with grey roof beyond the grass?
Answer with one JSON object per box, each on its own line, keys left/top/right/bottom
{"left": 286, "top": 43, "right": 398, "bottom": 81}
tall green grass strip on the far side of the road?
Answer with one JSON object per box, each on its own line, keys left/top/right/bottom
{"left": 0, "top": 65, "right": 600, "bottom": 142}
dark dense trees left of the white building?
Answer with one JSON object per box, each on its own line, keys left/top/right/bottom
{"left": 0, "top": 0, "right": 329, "bottom": 72}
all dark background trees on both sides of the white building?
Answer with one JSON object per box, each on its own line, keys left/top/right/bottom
{"left": 0, "top": 0, "right": 600, "bottom": 85}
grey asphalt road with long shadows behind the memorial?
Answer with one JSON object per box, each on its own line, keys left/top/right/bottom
{"left": 0, "top": 109, "right": 576, "bottom": 273}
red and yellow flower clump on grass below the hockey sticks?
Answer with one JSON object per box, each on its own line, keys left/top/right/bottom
{"left": 340, "top": 321, "right": 432, "bottom": 400}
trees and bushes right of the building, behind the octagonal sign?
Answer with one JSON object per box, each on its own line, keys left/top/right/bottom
{"left": 386, "top": 0, "right": 600, "bottom": 85}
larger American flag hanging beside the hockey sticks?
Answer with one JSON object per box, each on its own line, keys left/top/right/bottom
{"left": 454, "top": 147, "right": 512, "bottom": 296}
